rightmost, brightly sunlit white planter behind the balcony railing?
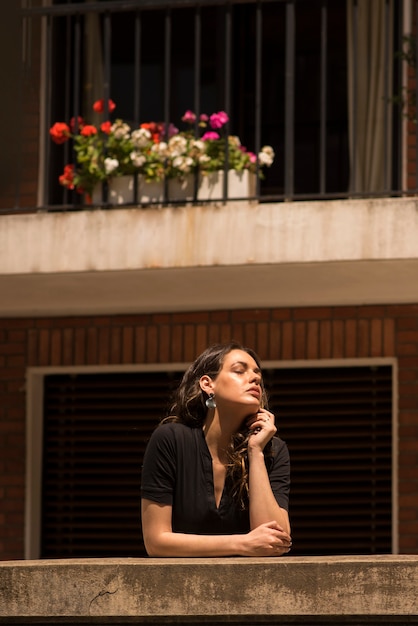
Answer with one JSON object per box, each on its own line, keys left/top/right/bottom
{"left": 197, "top": 170, "right": 256, "bottom": 201}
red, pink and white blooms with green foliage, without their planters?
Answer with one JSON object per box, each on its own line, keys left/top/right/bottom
{"left": 49, "top": 99, "right": 274, "bottom": 196}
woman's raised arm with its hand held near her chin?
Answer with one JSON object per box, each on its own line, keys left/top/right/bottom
{"left": 248, "top": 409, "right": 290, "bottom": 540}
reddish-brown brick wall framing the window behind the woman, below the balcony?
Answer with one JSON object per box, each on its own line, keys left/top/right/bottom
{"left": 0, "top": 305, "right": 418, "bottom": 559}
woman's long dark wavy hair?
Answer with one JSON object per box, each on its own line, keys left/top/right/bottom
{"left": 162, "top": 341, "right": 271, "bottom": 508}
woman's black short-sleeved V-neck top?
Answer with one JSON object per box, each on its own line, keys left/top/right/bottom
{"left": 141, "top": 422, "right": 290, "bottom": 535}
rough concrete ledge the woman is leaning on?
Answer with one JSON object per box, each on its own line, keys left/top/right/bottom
{"left": 0, "top": 555, "right": 418, "bottom": 624}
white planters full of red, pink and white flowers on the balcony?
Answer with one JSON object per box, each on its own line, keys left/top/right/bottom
{"left": 49, "top": 98, "right": 275, "bottom": 205}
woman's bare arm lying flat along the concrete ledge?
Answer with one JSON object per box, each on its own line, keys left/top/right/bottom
{"left": 141, "top": 499, "right": 290, "bottom": 557}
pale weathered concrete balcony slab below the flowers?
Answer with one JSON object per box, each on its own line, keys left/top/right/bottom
{"left": 0, "top": 198, "right": 418, "bottom": 316}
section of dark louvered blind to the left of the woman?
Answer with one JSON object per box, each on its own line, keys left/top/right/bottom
{"left": 41, "top": 372, "right": 178, "bottom": 558}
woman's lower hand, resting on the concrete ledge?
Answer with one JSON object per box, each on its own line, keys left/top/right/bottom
{"left": 242, "top": 521, "right": 292, "bottom": 556}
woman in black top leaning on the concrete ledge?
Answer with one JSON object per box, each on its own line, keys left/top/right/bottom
{"left": 141, "top": 343, "right": 292, "bottom": 557}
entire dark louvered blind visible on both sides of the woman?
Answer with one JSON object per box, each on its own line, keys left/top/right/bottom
{"left": 41, "top": 366, "right": 392, "bottom": 558}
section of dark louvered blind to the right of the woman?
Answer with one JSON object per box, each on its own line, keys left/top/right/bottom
{"left": 265, "top": 366, "right": 392, "bottom": 555}
